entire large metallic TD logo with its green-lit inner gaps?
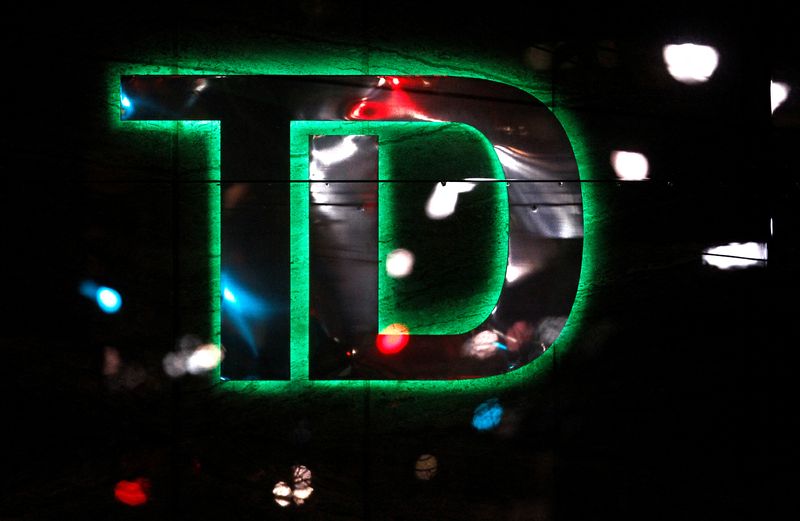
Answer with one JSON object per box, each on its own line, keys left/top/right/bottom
{"left": 121, "top": 75, "right": 583, "bottom": 380}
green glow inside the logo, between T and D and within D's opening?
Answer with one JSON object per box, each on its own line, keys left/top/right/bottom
{"left": 290, "top": 121, "right": 508, "bottom": 380}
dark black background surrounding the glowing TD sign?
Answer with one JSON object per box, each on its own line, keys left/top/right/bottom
{"left": 0, "top": 1, "right": 800, "bottom": 520}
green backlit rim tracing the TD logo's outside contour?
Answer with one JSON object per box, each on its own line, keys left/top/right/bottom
{"left": 107, "top": 50, "right": 600, "bottom": 397}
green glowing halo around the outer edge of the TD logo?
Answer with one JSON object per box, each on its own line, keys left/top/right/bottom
{"left": 107, "top": 39, "right": 602, "bottom": 400}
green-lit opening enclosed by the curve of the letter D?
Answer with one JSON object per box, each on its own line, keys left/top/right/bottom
{"left": 378, "top": 122, "right": 508, "bottom": 335}
